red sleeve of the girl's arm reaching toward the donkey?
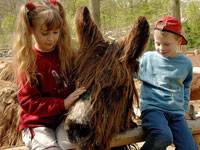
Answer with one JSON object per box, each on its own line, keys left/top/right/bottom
{"left": 17, "top": 76, "right": 66, "bottom": 117}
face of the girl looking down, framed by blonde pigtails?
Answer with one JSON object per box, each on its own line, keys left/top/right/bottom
{"left": 31, "top": 21, "right": 60, "bottom": 52}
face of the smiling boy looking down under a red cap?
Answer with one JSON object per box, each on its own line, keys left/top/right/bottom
{"left": 154, "top": 30, "right": 181, "bottom": 57}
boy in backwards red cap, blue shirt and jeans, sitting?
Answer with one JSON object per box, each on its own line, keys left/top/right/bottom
{"left": 139, "top": 16, "right": 198, "bottom": 150}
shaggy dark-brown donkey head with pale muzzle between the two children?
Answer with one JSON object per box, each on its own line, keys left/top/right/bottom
{"left": 66, "top": 7, "right": 149, "bottom": 150}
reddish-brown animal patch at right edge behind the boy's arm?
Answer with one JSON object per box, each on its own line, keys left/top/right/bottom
{"left": 190, "top": 73, "right": 200, "bottom": 100}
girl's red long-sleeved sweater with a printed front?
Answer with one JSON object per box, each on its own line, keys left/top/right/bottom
{"left": 18, "top": 48, "right": 73, "bottom": 130}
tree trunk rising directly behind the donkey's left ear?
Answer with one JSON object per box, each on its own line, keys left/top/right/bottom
{"left": 89, "top": 0, "right": 100, "bottom": 27}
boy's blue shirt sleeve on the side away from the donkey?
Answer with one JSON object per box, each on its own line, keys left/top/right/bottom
{"left": 183, "top": 65, "right": 193, "bottom": 112}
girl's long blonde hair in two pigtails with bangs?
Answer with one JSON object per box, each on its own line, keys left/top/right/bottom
{"left": 13, "top": 0, "right": 73, "bottom": 85}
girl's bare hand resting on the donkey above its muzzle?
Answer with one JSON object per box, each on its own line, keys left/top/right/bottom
{"left": 64, "top": 87, "right": 86, "bottom": 110}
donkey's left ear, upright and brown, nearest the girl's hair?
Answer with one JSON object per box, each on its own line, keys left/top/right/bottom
{"left": 75, "top": 7, "right": 104, "bottom": 48}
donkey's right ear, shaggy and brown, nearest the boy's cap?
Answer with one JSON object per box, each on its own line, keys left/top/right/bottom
{"left": 120, "top": 16, "right": 150, "bottom": 62}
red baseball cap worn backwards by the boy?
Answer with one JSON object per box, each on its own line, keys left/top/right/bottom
{"left": 154, "top": 16, "right": 187, "bottom": 45}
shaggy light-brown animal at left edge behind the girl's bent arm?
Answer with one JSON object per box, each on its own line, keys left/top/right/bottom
{"left": 0, "top": 80, "right": 22, "bottom": 147}
